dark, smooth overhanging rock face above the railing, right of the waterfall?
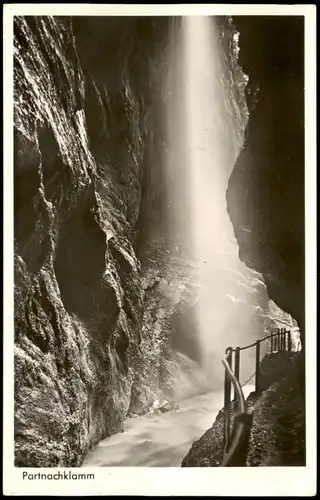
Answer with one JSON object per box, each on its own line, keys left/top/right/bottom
{"left": 227, "top": 16, "right": 305, "bottom": 340}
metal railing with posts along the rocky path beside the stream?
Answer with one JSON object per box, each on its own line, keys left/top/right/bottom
{"left": 221, "top": 328, "right": 292, "bottom": 467}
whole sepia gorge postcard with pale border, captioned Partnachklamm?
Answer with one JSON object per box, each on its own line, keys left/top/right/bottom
{"left": 4, "top": 4, "right": 316, "bottom": 496}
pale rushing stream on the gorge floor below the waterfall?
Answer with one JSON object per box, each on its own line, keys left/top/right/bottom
{"left": 83, "top": 385, "right": 254, "bottom": 467}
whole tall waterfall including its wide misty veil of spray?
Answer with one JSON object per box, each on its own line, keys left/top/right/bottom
{"left": 167, "top": 16, "right": 263, "bottom": 385}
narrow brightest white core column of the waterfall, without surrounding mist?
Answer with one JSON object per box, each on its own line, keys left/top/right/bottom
{"left": 183, "top": 16, "right": 240, "bottom": 382}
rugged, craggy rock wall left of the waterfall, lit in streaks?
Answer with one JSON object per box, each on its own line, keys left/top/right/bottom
{"left": 14, "top": 17, "right": 169, "bottom": 467}
